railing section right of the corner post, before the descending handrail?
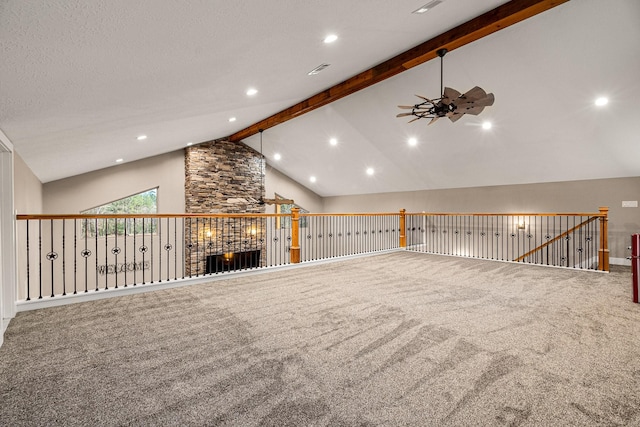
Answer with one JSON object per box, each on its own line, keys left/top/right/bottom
{"left": 406, "top": 207, "right": 609, "bottom": 271}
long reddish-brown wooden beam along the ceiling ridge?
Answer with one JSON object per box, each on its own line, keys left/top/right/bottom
{"left": 229, "top": 0, "right": 569, "bottom": 141}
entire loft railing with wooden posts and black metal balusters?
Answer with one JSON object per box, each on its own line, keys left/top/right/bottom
{"left": 12, "top": 208, "right": 609, "bottom": 301}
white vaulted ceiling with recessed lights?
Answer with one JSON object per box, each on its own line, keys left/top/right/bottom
{"left": 0, "top": 0, "right": 640, "bottom": 196}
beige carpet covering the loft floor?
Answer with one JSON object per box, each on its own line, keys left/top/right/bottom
{"left": 0, "top": 252, "right": 640, "bottom": 426}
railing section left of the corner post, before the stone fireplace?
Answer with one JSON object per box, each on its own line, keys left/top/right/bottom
{"left": 17, "top": 209, "right": 400, "bottom": 301}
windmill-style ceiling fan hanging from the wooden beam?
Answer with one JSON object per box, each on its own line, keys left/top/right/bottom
{"left": 396, "top": 48, "right": 494, "bottom": 124}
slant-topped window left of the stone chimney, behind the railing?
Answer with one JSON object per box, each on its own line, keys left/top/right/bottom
{"left": 80, "top": 188, "right": 158, "bottom": 237}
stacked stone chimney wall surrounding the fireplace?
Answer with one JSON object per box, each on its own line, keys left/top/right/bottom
{"left": 185, "top": 140, "right": 266, "bottom": 275}
